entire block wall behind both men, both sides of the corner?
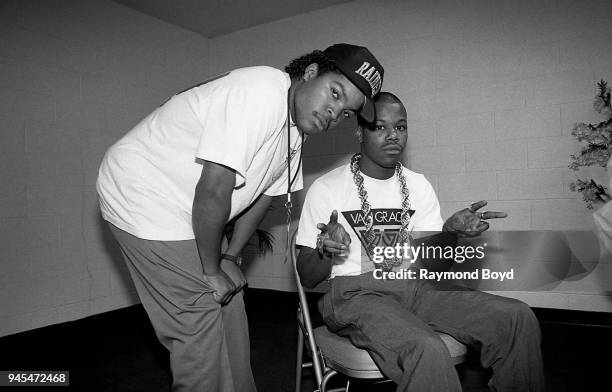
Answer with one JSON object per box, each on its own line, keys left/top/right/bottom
{"left": 0, "top": 0, "right": 612, "bottom": 336}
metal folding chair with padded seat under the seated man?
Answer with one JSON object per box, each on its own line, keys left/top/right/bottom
{"left": 289, "top": 231, "right": 467, "bottom": 392}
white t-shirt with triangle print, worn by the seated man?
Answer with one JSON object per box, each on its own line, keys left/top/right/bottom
{"left": 296, "top": 164, "right": 444, "bottom": 278}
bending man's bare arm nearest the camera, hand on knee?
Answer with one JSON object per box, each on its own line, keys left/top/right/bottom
{"left": 192, "top": 161, "right": 236, "bottom": 304}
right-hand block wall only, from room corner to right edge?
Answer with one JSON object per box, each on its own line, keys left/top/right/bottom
{"left": 210, "top": 0, "right": 612, "bottom": 311}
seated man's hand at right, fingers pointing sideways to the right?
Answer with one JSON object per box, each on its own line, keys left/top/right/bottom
{"left": 442, "top": 200, "right": 508, "bottom": 237}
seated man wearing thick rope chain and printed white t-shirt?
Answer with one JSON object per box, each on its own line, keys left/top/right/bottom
{"left": 296, "top": 93, "right": 544, "bottom": 392}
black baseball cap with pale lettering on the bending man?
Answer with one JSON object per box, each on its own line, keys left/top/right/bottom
{"left": 323, "top": 44, "right": 385, "bottom": 122}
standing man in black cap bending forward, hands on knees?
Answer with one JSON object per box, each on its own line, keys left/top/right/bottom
{"left": 97, "top": 44, "right": 384, "bottom": 392}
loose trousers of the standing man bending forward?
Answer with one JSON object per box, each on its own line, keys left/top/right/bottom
{"left": 109, "top": 224, "right": 256, "bottom": 392}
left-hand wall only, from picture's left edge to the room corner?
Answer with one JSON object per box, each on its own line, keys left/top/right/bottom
{"left": 0, "top": 0, "right": 209, "bottom": 336}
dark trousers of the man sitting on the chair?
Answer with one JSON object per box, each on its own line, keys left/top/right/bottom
{"left": 319, "top": 273, "right": 544, "bottom": 392}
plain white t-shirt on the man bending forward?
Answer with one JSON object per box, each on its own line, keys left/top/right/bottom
{"left": 96, "top": 66, "right": 302, "bottom": 241}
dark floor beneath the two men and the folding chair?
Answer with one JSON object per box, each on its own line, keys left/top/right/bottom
{"left": 0, "top": 289, "right": 612, "bottom": 392}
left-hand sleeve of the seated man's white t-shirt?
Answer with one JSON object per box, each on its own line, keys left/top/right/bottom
{"left": 295, "top": 180, "right": 334, "bottom": 249}
